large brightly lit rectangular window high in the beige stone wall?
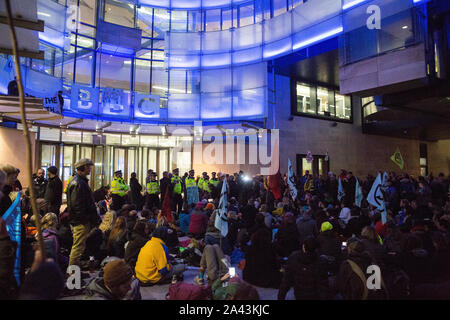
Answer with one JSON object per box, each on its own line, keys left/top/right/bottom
{"left": 292, "top": 82, "right": 352, "bottom": 121}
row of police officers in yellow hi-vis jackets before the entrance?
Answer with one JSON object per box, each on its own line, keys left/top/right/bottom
{"left": 110, "top": 168, "right": 220, "bottom": 213}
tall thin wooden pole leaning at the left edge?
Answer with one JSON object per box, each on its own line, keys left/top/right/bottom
{"left": 5, "top": 0, "right": 45, "bottom": 261}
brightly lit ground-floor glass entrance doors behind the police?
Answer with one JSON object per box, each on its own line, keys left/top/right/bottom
{"left": 31, "top": 126, "right": 193, "bottom": 190}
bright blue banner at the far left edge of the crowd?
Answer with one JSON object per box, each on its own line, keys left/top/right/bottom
{"left": 2, "top": 193, "right": 22, "bottom": 286}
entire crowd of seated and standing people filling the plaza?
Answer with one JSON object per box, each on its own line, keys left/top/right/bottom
{"left": 0, "top": 159, "right": 450, "bottom": 300}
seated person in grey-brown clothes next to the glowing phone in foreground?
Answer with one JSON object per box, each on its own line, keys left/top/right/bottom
{"left": 194, "top": 244, "right": 230, "bottom": 285}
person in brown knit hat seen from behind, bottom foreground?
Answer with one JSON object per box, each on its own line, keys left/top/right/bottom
{"left": 85, "top": 259, "right": 141, "bottom": 300}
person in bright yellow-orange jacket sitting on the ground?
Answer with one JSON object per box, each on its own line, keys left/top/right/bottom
{"left": 135, "top": 227, "right": 185, "bottom": 285}
